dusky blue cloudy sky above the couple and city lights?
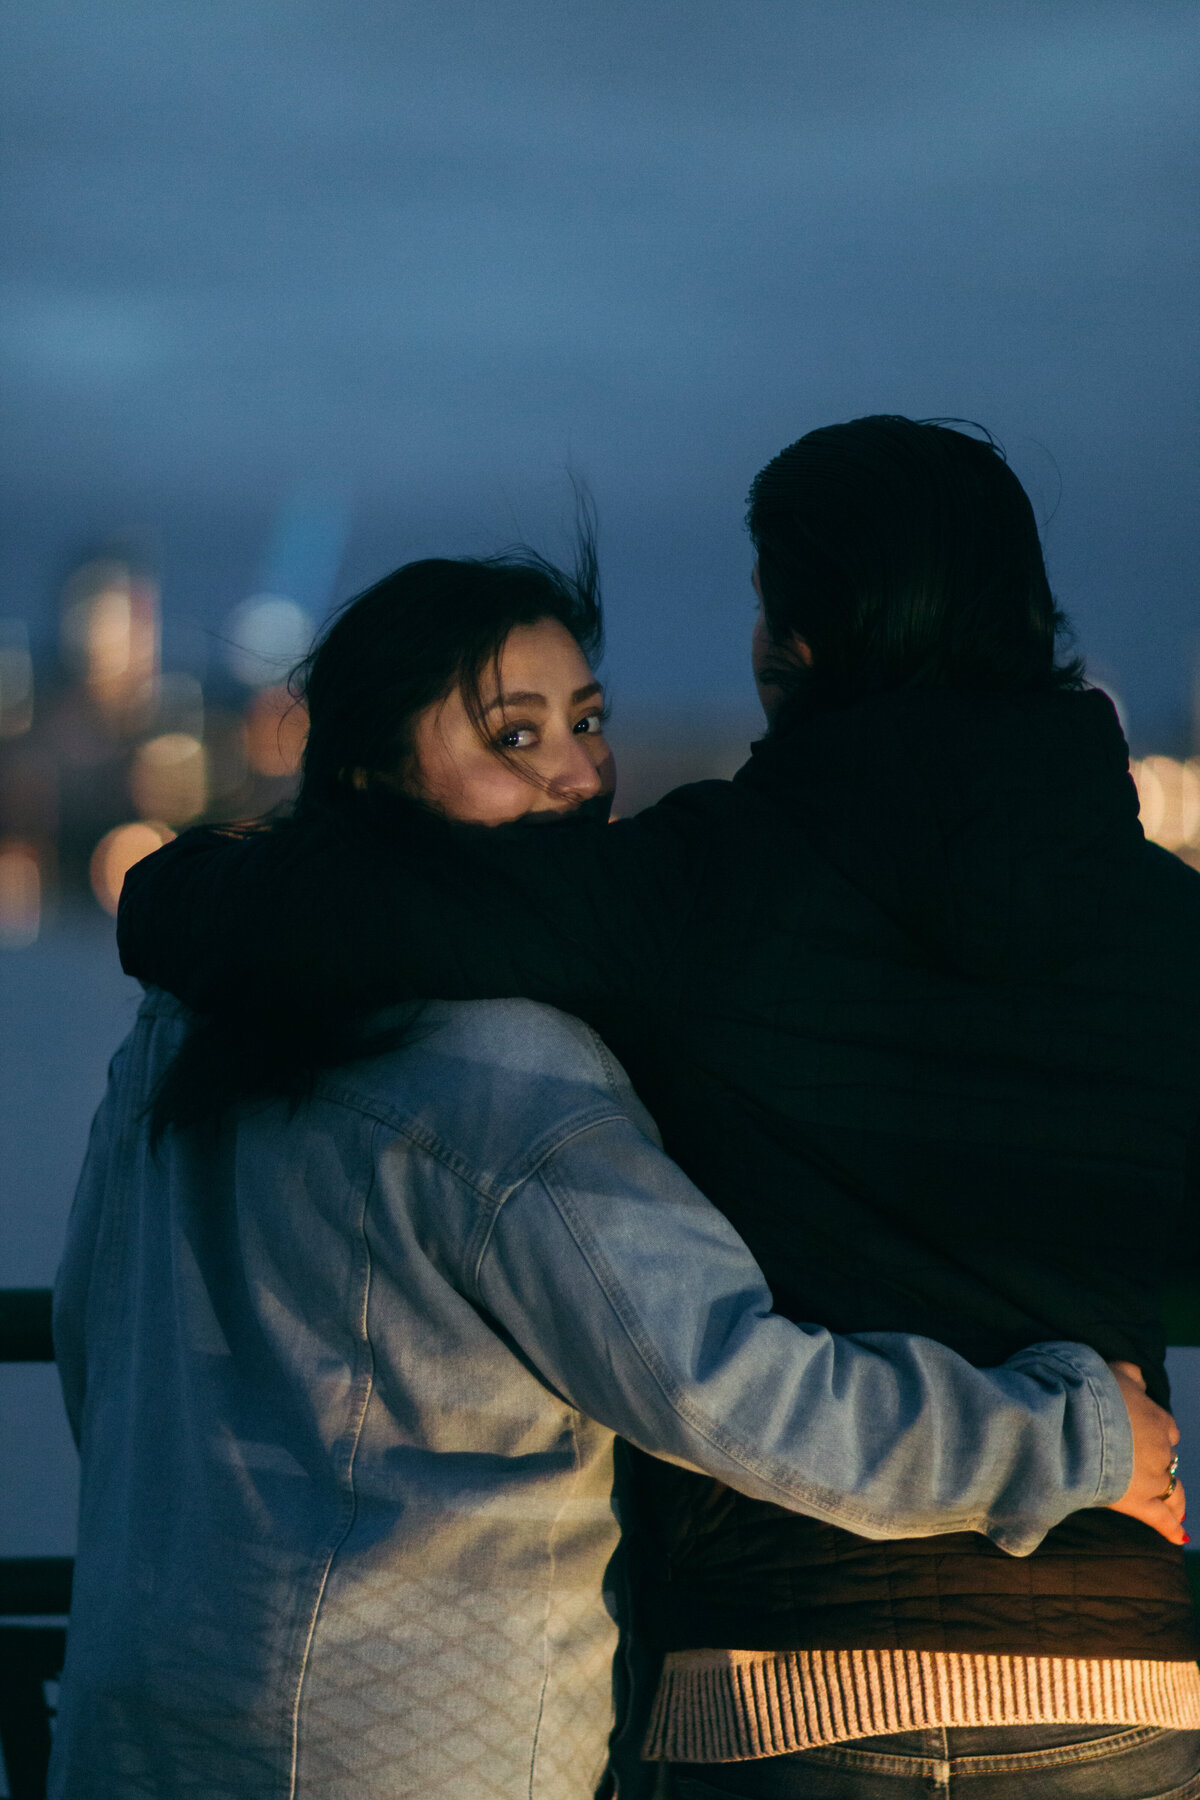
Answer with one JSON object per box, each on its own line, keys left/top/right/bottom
{"left": 0, "top": 0, "right": 1200, "bottom": 749}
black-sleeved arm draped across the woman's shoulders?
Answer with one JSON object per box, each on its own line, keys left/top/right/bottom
{"left": 119, "top": 799, "right": 709, "bottom": 1013}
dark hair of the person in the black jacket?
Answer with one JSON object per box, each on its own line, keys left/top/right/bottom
{"left": 747, "top": 414, "right": 1083, "bottom": 700}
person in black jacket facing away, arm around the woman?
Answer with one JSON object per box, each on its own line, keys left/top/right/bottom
{"left": 122, "top": 416, "right": 1200, "bottom": 1800}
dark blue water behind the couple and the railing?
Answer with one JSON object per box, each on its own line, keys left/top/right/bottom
{"left": 0, "top": 913, "right": 1200, "bottom": 1555}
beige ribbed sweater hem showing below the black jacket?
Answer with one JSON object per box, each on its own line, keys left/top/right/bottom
{"left": 642, "top": 1651, "right": 1200, "bottom": 1762}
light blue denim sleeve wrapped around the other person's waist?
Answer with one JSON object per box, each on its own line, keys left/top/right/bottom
{"left": 473, "top": 1118, "right": 1132, "bottom": 1555}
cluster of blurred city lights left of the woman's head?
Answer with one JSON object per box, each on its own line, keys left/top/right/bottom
{"left": 0, "top": 556, "right": 322, "bottom": 950}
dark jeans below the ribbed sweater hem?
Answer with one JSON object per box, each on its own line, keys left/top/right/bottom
{"left": 667, "top": 1724, "right": 1200, "bottom": 1800}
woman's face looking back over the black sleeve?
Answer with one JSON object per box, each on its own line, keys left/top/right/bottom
{"left": 410, "top": 619, "right": 615, "bottom": 824}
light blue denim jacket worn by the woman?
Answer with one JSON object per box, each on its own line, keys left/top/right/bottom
{"left": 52, "top": 992, "right": 1132, "bottom": 1800}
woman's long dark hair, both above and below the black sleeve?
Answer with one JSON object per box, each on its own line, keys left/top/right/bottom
{"left": 151, "top": 525, "right": 603, "bottom": 1145}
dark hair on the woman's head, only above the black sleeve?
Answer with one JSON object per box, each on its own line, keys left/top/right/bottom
{"left": 291, "top": 518, "right": 603, "bottom": 814}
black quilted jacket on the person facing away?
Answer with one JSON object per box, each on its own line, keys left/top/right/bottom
{"left": 122, "top": 689, "right": 1200, "bottom": 1660}
